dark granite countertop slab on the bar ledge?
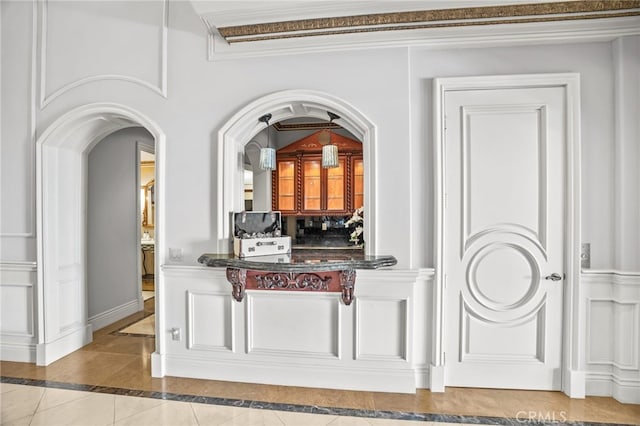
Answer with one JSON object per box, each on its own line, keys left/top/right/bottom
{"left": 198, "top": 249, "right": 397, "bottom": 272}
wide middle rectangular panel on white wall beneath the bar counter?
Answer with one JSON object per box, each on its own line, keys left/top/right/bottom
{"left": 246, "top": 291, "right": 341, "bottom": 358}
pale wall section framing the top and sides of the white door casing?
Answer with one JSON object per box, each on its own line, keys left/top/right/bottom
{"left": 411, "top": 43, "right": 614, "bottom": 268}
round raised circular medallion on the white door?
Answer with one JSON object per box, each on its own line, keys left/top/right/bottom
{"left": 467, "top": 243, "right": 540, "bottom": 311}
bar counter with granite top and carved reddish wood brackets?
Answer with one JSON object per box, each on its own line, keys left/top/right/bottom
{"left": 198, "top": 249, "right": 397, "bottom": 305}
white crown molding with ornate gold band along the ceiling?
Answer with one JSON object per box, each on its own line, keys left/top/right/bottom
{"left": 201, "top": 0, "right": 640, "bottom": 60}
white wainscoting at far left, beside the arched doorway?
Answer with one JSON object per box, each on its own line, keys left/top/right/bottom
{"left": 0, "top": 262, "right": 37, "bottom": 362}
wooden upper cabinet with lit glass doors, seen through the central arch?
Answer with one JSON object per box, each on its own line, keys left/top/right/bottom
{"left": 272, "top": 131, "right": 364, "bottom": 216}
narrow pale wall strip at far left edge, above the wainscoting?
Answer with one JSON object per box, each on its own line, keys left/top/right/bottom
{"left": 0, "top": 2, "right": 36, "bottom": 261}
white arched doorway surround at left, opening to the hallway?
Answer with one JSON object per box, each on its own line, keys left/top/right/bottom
{"left": 36, "top": 103, "right": 166, "bottom": 365}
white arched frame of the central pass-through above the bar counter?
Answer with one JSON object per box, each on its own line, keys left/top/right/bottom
{"left": 217, "top": 89, "right": 377, "bottom": 254}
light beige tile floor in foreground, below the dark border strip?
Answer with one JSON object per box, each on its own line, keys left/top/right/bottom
{"left": 0, "top": 383, "right": 470, "bottom": 426}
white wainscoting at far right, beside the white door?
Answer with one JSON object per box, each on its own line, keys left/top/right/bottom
{"left": 581, "top": 271, "right": 640, "bottom": 404}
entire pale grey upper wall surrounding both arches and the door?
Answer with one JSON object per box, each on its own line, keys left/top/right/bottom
{"left": 0, "top": 1, "right": 640, "bottom": 400}
